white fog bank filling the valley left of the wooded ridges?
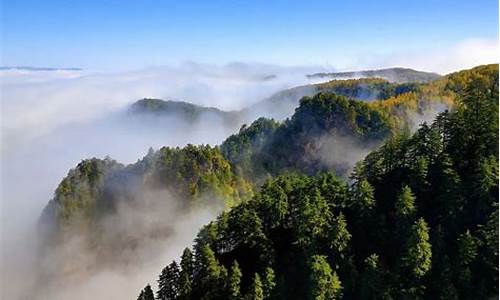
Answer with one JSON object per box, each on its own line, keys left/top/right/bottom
{"left": 0, "top": 63, "right": 321, "bottom": 299}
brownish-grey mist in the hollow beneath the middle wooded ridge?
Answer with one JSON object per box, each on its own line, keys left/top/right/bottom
{"left": 12, "top": 189, "right": 223, "bottom": 300}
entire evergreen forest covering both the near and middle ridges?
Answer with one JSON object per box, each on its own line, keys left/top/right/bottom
{"left": 37, "top": 65, "right": 498, "bottom": 300}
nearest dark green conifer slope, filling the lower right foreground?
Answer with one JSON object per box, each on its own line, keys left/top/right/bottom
{"left": 139, "top": 66, "right": 498, "bottom": 299}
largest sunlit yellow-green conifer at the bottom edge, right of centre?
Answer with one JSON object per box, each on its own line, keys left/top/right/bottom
{"left": 309, "top": 255, "right": 342, "bottom": 300}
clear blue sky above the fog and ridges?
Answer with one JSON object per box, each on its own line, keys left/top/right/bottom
{"left": 1, "top": 0, "right": 498, "bottom": 69}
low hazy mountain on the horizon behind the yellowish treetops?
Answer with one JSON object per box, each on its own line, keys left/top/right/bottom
{"left": 307, "top": 68, "right": 441, "bottom": 83}
